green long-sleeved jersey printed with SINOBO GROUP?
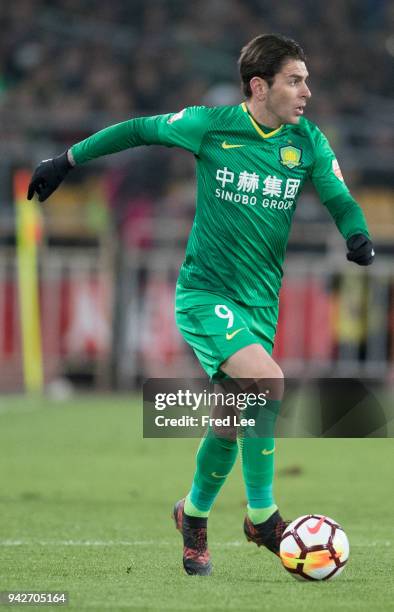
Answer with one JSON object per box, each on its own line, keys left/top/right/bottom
{"left": 71, "top": 103, "right": 368, "bottom": 306}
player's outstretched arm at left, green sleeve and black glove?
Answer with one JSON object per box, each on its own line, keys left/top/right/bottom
{"left": 27, "top": 106, "right": 212, "bottom": 202}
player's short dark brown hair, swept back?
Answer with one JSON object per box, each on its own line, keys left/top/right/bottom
{"left": 238, "top": 34, "right": 306, "bottom": 98}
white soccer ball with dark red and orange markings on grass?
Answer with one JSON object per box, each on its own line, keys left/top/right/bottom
{"left": 279, "top": 514, "right": 349, "bottom": 580}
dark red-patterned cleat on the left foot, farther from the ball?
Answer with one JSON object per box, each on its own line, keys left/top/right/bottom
{"left": 173, "top": 499, "right": 212, "bottom": 576}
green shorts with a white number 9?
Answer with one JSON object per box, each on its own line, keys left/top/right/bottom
{"left": 175, "top": 285, "right": 278, "bottom": 378}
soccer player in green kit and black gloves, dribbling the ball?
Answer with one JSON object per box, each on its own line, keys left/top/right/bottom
{"left": 28, "top": 34, "right": 374, "bottom": 575}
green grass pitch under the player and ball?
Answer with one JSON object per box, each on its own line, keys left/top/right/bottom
{"left": 0, "top": 395, "right": 394, "bottom": 612}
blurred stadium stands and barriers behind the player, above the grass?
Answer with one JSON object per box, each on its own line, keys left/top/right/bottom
{"left": 0, "top": 0, "right": 394, "bottom": 390}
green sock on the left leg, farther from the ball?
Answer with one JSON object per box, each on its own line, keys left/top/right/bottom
{"left": 185, "top": 430, "right": 238, "bottom": 517}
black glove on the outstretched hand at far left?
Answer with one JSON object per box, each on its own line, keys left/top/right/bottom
{"left": 27, "top": 151, "right": 73, "bottom": 202}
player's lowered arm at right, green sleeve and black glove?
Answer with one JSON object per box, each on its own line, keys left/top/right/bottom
{"left": 311, "top": 129, "right": 375, "bottom": 266}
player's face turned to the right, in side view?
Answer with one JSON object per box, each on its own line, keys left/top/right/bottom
{"left": 265, "top": 59, "right": 311, "bottom": 124}
